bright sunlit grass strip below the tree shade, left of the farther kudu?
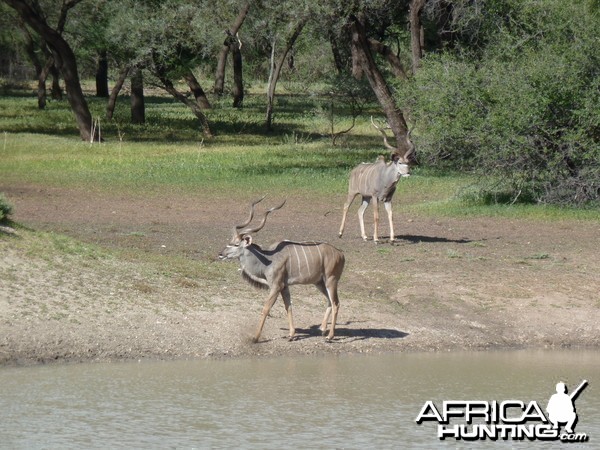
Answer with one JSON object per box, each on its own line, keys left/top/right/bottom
{"left": 0, "top": 133, "right": 374, "bottom": 192}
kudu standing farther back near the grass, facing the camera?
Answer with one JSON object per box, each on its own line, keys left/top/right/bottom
{"left": 339, "top": 118, "right": 415, "bottom": 242}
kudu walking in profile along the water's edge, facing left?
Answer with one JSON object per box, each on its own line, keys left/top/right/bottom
{"left": 219, "top": 197, "right": 345, "bottom": 342}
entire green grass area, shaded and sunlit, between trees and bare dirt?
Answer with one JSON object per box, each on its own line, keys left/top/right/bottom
{"left": 0, "top": 88, "right": 600, "bottom": 220}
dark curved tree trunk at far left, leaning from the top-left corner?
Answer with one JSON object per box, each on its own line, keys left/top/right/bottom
{"left": 4, "top": 0, "right": 95, "bottom": 141}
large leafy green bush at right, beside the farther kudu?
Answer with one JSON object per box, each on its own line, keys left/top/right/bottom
{"left": 399, "top": 0, "right": 600, "bottom": 205}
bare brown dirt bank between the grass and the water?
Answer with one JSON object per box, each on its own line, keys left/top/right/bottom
{"left": 0, "top": 183, "right": 600, "bottom": 365}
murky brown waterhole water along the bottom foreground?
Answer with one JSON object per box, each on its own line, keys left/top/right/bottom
{"left": 0, "top": 350, "right": 600, "bottom": 449}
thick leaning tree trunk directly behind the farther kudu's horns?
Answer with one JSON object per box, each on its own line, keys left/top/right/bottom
{"left": 350, "top": 16, "right": 409, "bottom": 155}
